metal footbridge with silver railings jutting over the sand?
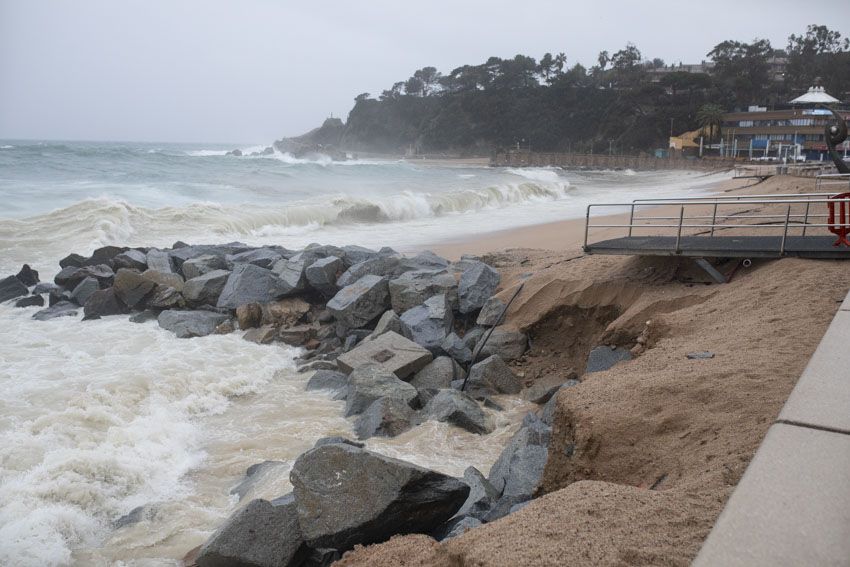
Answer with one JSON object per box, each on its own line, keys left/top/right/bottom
{"left": 584, "top": 174, "right": 850, "bottom": 259}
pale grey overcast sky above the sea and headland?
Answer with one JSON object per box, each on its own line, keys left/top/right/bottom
{"left": 0, "top": 0, "right": 850, "bottom": 143}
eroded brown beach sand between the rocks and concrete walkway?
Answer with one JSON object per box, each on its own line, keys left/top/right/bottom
{"left": 339, "top": 177, "right": 850, "bottom": 567}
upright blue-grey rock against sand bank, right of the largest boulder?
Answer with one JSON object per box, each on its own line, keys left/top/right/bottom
{"left": 487, "top": 413, "right": 552, "bottom": 522}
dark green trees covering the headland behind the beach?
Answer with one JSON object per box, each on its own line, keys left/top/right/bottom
{"left": 322, "top": 25, "right": 850, "bottom": 154}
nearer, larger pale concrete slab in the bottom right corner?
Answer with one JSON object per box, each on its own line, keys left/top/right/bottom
{"left": 693, "top": 423, "right": 850, "bottom": 567}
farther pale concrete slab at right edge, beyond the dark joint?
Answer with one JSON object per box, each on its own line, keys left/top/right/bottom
{"left": 779, "top": 311, "right": 850, "bottom": 433}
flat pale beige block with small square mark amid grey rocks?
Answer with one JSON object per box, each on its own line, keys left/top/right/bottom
{"left": 337, "top": 331, "right": 433, "bottom": 379}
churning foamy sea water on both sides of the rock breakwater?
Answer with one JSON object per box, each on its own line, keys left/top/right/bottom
{"left": 0, "top": 141, "right": 718, "bottom": 566}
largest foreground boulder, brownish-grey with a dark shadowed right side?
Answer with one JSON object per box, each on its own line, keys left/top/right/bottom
{"left": 290, "top": 444, "right": 469, "bottom": 551}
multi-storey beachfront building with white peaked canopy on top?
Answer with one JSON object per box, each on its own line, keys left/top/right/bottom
{"left": 720, "top": 86, "right": 850, "bottom": 161}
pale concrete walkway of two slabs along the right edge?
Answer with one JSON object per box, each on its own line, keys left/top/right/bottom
{"left": 693, "top": 294, "right": 850, "bottom": 567}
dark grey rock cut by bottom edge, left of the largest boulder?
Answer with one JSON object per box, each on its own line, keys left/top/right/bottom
{"left": 195, "top": 498, "right": 310, "bottom": 567}
